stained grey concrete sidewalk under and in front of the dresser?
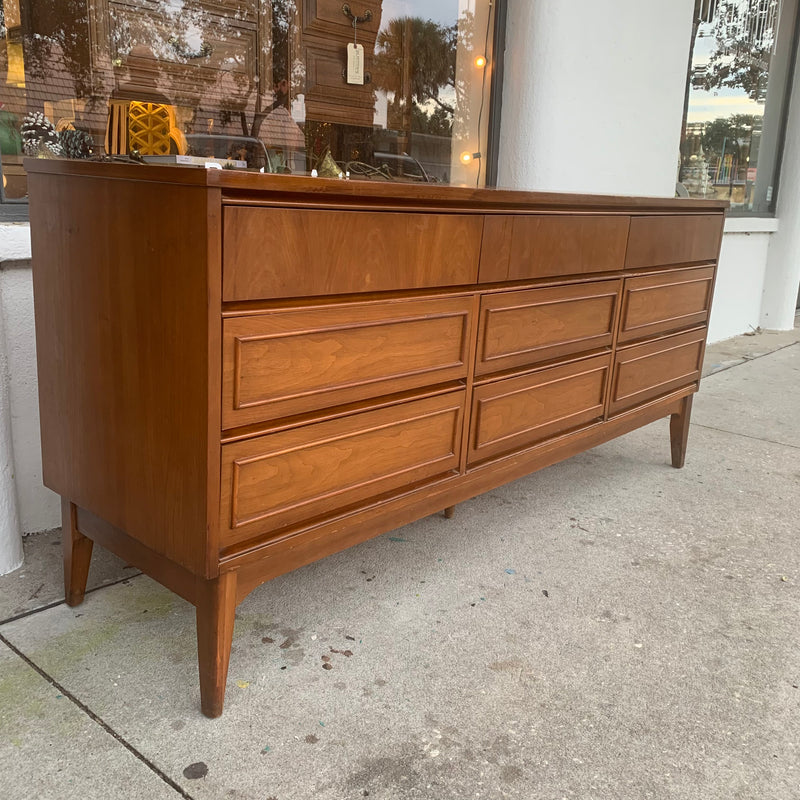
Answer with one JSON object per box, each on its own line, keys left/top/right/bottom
{"left": 0, "top": 324, "right": 800, "bottom": 800}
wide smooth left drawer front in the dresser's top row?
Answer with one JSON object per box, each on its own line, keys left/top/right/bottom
{"left": 222, "top": 207, "right": 483, "bottom": 300}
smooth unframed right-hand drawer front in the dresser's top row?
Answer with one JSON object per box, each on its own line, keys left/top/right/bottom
{"left": 625, "top": 214, "right": 724, "bottom": 267}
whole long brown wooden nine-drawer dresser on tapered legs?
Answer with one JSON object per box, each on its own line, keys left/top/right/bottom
{"left": 26, "top": 161, "right": 725, "bottom": 716}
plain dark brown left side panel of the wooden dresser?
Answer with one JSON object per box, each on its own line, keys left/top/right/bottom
{"left": 30, "top": 174, "right": 214, "bottom": 574}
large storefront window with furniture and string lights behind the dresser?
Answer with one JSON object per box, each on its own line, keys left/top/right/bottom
{"left": 0, "top": 0, "right": 496, "bottom": 202}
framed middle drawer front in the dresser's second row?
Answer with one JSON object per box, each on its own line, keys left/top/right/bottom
{"left": 475, "top": 280, "right": 620, "bottom": 375}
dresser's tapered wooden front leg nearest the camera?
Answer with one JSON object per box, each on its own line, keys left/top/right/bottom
{"left": 197, "top": 572, "right": 236, "bottom": 717}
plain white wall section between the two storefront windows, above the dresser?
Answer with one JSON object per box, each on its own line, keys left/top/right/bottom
{"left": 499, "top": 0, "right": 694, "bottom": 197}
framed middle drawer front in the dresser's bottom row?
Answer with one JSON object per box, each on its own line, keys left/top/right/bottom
{"left": 468, "top": 355, "right": 611, "bottom": 465}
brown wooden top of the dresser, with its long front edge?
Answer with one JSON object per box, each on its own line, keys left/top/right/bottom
{"left": 25, "top": 159, "right": 728, "bottom": 214}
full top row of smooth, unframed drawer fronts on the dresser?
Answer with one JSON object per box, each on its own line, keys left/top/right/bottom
{"left": 222, "top": 206, "right": 723, "bottom": 301}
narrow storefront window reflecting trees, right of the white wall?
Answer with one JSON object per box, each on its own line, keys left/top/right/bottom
{"left": 678, "top": 0, "right": 797, "bottom": 214}
